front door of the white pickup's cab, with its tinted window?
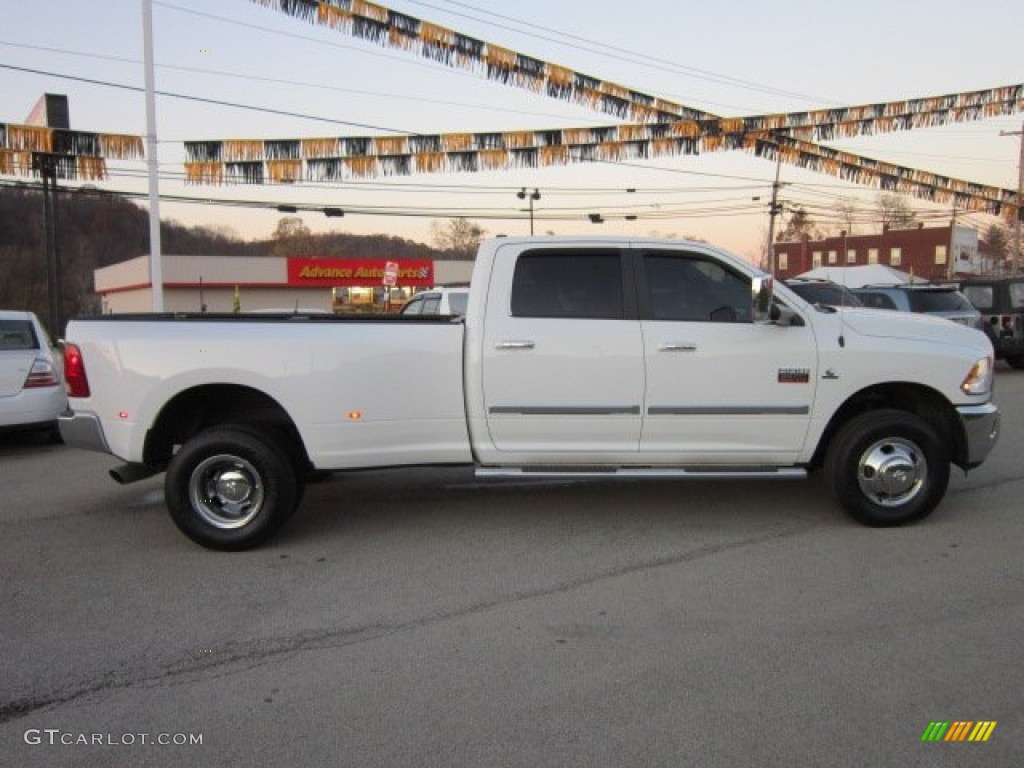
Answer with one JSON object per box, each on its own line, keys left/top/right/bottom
{"left": 637, "top": 247, "right": 817, "bottom": 465}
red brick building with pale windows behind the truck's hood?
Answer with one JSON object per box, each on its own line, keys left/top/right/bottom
{"left": 774, "top": 224, "right": 984, "bottom": 281}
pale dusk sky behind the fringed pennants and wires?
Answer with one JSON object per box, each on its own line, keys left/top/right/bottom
{"left": 0, "top": 0, "right": 1024, "bottom": 258}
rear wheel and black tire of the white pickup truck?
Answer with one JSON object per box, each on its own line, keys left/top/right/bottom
{"left": 164, "top": 427, "right": 299, "bottom": 550}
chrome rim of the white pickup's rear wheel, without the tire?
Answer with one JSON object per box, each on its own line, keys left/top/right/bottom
{"left": 188, "top": 454, "right": 265, "bottom": 530}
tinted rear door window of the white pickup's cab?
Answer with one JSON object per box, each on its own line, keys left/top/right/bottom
{"left": 512, "top": 252, "right": 625, "bottom": 319}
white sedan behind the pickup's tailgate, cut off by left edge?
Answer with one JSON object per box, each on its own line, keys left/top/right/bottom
{"left": 0, "top": 310, "right": 68, "bottom": 440}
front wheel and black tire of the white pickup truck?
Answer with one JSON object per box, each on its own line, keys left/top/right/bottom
{"left": 825, "top": 410, "right": 949, "bottom": 527}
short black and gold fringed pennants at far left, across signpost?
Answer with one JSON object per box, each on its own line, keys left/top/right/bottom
{"left": 0, "top": 123, "right": 142, "bottom": 181}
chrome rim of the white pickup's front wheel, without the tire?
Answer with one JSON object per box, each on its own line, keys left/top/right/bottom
{"left": 857, "top": 437, "right": 928, "bottom": 508}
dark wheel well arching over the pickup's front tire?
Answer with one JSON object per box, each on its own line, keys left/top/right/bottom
{"left": 811, "top": 382, "right": 967, "bottom": 469}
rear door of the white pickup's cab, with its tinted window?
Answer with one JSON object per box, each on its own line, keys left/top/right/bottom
{"left": 477, "top": 249, "right": 644, "bottom": 464}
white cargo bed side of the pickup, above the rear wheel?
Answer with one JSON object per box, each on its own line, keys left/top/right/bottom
{"left": 66, "top": 313, "right": 471, "bottom": 469}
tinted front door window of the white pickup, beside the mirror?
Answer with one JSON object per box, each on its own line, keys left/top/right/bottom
{"left": 643, "top": 253, "right": 752, "bottom": 323}
